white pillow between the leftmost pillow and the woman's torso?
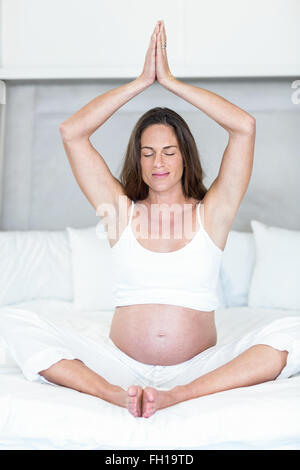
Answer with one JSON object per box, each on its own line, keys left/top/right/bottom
{"left": 67, "top": 224, "right": 115, "bottom": 310}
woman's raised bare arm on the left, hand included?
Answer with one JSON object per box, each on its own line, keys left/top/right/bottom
{"left": 59, "top": 20, "right": 158, "bottom": 222}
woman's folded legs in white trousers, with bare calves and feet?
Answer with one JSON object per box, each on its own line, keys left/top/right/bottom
{"left": 0, "top": 309, "right": 294, "bottom": 418}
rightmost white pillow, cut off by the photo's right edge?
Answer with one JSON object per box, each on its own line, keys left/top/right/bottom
{"left": 248, "top": 220, "right": 300, "bottom": 310}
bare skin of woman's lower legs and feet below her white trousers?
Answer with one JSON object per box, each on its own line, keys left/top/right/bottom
{"left": 40, "top": 344, "right": 288, "bottom": 418}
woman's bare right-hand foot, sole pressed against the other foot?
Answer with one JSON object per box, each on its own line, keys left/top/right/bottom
{"left": 142, "top": 387, "right": 180, "bottom": 418}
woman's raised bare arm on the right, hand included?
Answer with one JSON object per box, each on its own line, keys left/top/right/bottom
{"left": 156, "top": 23, "right": 256, "bottom": 222}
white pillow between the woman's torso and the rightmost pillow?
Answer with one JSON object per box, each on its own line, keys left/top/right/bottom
{"left": 220, "top": 230, "right": 255, "bottom": 307}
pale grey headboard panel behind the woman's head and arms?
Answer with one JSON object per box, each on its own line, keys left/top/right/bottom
{"left": 0, "top": 79, "right": 300, "bottom": 231}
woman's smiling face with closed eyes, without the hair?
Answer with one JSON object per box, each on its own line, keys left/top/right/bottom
{"left": 141, "top": 124, "right": 183, "bottom": 195}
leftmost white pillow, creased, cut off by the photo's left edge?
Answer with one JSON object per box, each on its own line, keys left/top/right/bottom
{"left": 0, "top": 230, "right": 73, "bottom": 307}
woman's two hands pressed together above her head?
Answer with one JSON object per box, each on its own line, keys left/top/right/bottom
{"left": 139, "top": 20, "right": 174, "bottom": 86}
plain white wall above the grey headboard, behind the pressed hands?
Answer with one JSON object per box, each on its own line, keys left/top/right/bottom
{"left": 0, "top": 0, "right": 300, "bottom": 78}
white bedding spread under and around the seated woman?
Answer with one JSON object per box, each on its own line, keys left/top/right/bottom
{"left": 0, "top": 300, "right": 300, "bottom": 449}
